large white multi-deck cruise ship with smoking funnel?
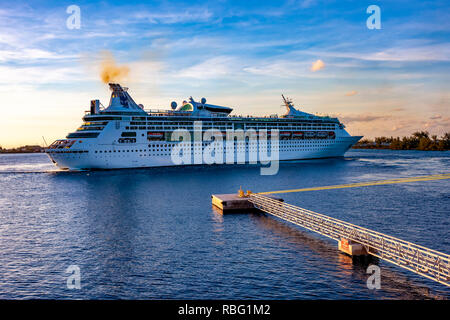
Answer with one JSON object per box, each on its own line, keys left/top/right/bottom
{"left": 45, "top": 83, "right": 362, "bottom": 170}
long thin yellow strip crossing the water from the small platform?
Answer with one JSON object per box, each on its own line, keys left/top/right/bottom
{"left": 258, "top": 173, "right": 450, "bottom": 194}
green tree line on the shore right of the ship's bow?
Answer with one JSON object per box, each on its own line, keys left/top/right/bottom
{"left": 353, "top": 131, "right": 450, "bottom": 151}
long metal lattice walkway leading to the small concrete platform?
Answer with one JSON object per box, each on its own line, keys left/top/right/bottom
{"left": 248, "top": 194, "right": 450, "bottom": 286}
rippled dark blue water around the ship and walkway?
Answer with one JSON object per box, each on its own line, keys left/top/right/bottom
{"left": 0, "top": 150, "right": 450, "bottom": 299}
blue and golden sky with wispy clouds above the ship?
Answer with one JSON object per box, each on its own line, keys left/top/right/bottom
{"left": 0, "top": 0, "right": 450, "bottom": 147}
